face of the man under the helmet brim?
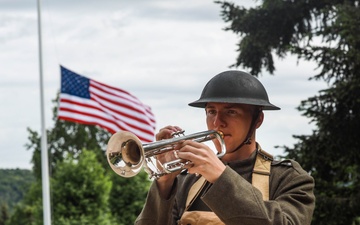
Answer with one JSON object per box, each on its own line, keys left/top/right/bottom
{"left": 205, "top": 102, "right": 254, "bottom": 153}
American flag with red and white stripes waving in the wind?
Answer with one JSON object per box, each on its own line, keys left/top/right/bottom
{"left": 58, "top": 66, "right": 155, "bottom": 143}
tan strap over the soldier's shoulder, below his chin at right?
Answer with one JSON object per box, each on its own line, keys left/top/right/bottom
{"left": 252, "top": 146, "right": 273, "bottom": 201}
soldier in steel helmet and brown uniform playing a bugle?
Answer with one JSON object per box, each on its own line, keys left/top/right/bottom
{"left": 135, "top": 71, "right": 315, "bottom": 225}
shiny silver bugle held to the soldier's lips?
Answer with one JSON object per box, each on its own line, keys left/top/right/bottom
{"left": 106, "top": 130, "right": 226, "bottom": 179}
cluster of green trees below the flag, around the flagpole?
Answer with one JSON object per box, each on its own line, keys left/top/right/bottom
{"left": 7, "top": 94, "right": 150, "bottom": 225}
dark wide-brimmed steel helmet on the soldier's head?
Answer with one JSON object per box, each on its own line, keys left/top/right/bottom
{"left": 189, "top": 70, "right": 280, "bottom": 110}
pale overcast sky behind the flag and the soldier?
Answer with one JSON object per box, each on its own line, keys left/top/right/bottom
{"left": 0, "top": 0, "right": 325, "bottom": 169}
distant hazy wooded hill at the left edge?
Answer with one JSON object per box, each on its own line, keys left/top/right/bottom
{"left": 0, "top": 169, "right": 35, "bottom": 213}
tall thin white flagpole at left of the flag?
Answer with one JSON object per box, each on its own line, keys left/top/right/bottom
{"left": 37, "top": 0, "right": 51, "bottom": 225}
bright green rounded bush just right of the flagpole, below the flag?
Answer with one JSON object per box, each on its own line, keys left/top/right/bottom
{"left": 51, "top": 150, "right": 112, "bottom": 225}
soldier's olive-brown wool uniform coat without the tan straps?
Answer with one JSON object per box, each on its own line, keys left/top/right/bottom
{"left": 135, "top": 146, "right": 315, "bottom": 225}
